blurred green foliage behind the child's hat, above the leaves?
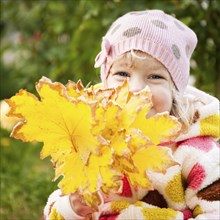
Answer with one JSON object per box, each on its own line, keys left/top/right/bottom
{"left": 0, "top": 0, "right": 220, "bottom": 99}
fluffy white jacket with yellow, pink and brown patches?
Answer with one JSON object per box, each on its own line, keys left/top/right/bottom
{"left": 44, "top": 87, "right": 220, "bottom": 220}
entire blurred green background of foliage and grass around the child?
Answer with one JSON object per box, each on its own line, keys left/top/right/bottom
{"left": 0, "top": 0, "right": 220, "bottom": 219}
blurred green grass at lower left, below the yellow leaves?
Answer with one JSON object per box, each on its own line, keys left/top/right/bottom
{"left": 0, "top": 129, "right": 57, "bottom": 220}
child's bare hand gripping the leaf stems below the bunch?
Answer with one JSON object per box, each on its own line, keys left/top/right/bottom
{"left": 69, "top": 193, "right": 94, "bottom": 217}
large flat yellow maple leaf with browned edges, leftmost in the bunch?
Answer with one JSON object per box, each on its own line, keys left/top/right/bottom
{"left": 7, "top": 76, "right": 99, "bottom": 163}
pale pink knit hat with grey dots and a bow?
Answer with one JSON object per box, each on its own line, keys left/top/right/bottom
{"left": 95, "top": 10, "right": 197, "bottom": 92}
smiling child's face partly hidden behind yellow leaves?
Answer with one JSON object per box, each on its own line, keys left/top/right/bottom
{"left": 106, "top": 54, "right": 173, "bottom": 116}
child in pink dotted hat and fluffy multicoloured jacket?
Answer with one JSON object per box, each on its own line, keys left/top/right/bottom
{"left": 44, "top": 10, "right": 220, "bottom": 220}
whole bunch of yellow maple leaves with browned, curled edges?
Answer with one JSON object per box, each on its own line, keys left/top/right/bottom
{"left": 7, "top": 77, "right": 180, "bottom": 203}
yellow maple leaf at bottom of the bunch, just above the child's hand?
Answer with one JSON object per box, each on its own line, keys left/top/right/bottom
{"left": 56, "top": 147, "right": 115, "bottom": 194}
